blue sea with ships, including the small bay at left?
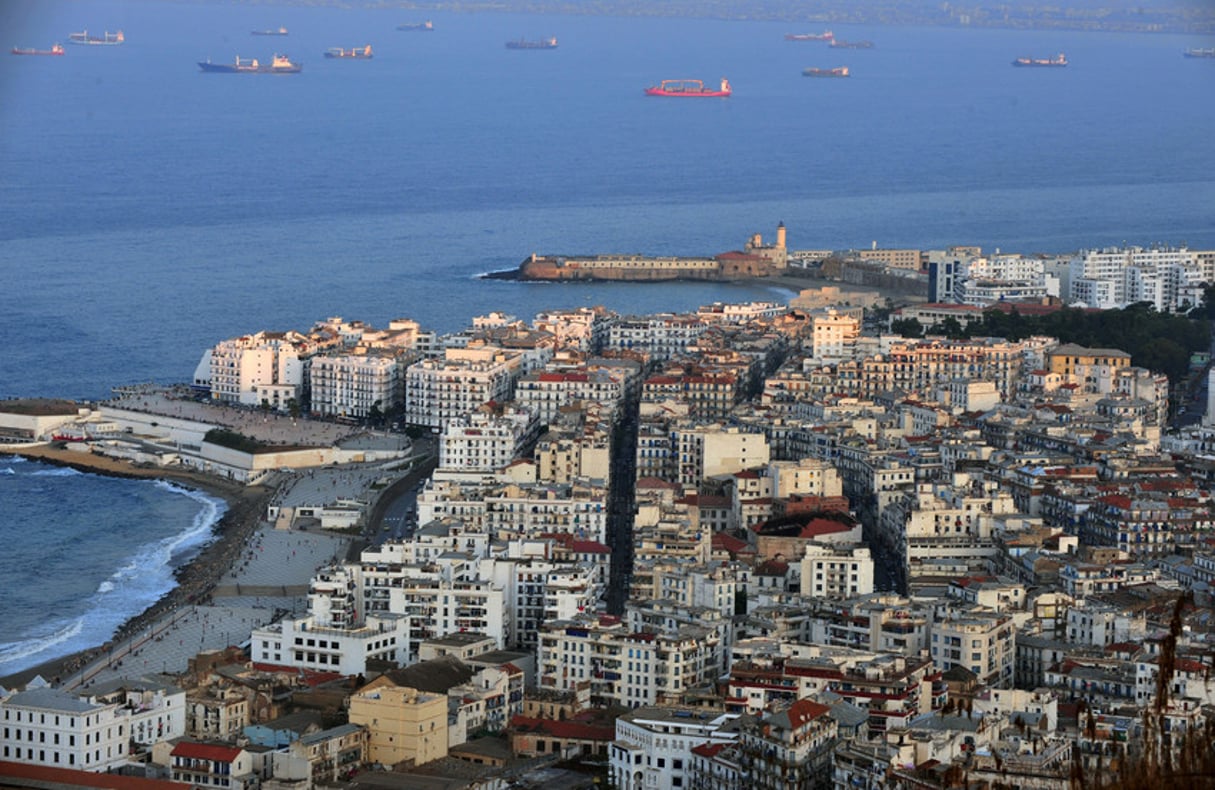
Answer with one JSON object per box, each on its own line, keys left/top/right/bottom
{"left": 0, "top": 0, "right": 1215, "bottom": 676}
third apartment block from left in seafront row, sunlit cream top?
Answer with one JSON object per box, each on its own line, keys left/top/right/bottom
{"left": 405, "top": 346, "right": 524, "bottom": 429}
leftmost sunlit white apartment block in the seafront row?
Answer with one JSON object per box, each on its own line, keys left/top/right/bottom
{"left": 194, "top": 332, "right": 315, "bottom": 410}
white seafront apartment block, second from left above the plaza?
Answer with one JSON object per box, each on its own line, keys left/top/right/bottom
{"left": 309, "top": 351, "right": 411, "bottom": 419}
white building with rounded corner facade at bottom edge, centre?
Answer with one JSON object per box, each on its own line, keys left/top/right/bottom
{"left": 609, "top": 707, "right": 739, "bottom": 790}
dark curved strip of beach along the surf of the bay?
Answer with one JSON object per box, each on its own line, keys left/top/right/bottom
{"left": 0, "top": 446, "right": 273, "bottom": 688}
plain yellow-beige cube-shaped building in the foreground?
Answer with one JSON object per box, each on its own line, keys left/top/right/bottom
{"left": 350, "top": 679, "right": 447, "bottom": 766}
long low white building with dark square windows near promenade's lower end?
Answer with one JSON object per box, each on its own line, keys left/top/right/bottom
{"left": 249, "top": 605, "right": 409, "bottom": 676}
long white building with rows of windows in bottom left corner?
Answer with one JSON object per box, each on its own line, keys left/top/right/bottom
{"left": 0, "top": 681, "right": 186, "bottom": 772}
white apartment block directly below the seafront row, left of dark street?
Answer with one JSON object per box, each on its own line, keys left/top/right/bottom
{"left": 439, "top": 408, "right": 538, "bottom": 472}
